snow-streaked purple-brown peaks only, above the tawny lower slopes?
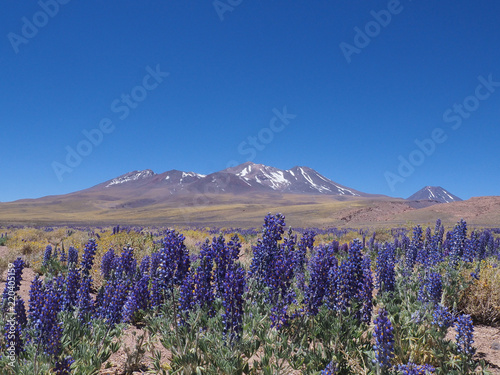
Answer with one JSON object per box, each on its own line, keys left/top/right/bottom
{"left": 91, "top": 162, "right": 462, "bottom": 203}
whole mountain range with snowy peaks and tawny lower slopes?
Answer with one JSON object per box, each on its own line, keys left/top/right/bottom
{"left": 0, "top": 162, "right": 500, "bottom": 227}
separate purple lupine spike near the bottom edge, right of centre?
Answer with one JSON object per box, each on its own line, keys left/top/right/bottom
{"left": 373, "top": 308, "right": 394, "bottom": 370}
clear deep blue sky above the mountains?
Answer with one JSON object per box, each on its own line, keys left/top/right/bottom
{"left": 0, "top": 0, "right": 500, "bottom": 201}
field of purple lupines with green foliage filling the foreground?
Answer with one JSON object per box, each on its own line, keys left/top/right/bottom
{"left": 0, "top": 214, "right": 500, "bottom": 375}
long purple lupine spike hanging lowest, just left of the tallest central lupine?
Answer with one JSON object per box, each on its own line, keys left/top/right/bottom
{"left": 222, "top": 265, "right": 245, "bottom": 343}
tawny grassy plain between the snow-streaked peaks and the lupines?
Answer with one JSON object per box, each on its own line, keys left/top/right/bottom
{"left": 0, "top": 192, "right": 500, "bottom": 227}
